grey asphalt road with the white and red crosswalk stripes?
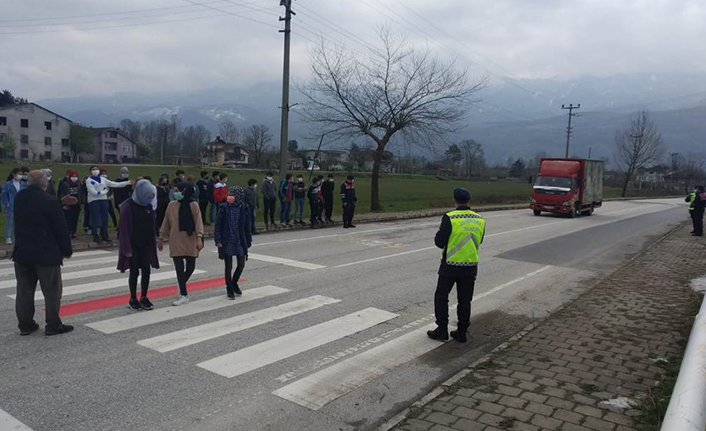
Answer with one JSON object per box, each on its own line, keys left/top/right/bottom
{"left": 0, "top": 199, "right": 687, "bottom": 431}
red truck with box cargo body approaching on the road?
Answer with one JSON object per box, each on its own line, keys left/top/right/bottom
{"left": 530, "top": 159, "right": 603, "bottom": 218}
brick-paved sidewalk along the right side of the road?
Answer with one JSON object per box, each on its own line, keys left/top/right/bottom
{"left": 382, "top": 226, "right": 706, "bottom": 431}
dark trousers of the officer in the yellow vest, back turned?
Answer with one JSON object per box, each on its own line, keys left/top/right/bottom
{"left": 434, "top": 268, "right": 478, "bottom": 330}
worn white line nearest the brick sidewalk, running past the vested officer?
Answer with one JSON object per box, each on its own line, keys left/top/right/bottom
{"left": 272, "top": 267, "right": 551, "bottom": 410}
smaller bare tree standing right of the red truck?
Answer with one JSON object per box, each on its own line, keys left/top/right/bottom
{"left": 615, "top": 110, "right": 664, "bottom": 197}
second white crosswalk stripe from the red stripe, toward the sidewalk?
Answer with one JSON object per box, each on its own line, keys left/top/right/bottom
{"left": 137, "top": 295, "right": 341, "bottom": 353}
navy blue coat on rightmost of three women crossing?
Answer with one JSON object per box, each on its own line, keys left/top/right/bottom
{"left": 214, "top": 203, "right": 252, "bottom": 259}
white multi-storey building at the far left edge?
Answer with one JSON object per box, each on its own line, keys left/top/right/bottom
{"left": 0, "top": 103, "right": 72, "bottom": 161}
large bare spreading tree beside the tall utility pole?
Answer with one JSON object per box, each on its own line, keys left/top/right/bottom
{"left": 300, "top": 29, "right": 486, "bottom": 211}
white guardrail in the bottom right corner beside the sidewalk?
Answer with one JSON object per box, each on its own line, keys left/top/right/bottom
{"left": 661, "top": 294, "right": 706, "bottom": 431}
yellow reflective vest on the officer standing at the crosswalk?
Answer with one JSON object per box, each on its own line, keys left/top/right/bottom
{"left": 446, "top": 210, "right": 485, "bottom": 266}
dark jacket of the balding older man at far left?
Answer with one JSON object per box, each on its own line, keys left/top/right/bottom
{"left": 12, "top": 187, "right": 73, "bottom": 265}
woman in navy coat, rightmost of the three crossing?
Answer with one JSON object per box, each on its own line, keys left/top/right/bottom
{"left": 214, "top": 186, "right": 252, "bottom": 299}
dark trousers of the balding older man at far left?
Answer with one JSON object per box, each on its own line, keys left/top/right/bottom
{"left": 15, "top": 262, "right": 62, "bottom": 331}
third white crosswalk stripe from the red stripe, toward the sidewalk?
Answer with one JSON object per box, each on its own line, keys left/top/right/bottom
{"left": 197, "top": 308, "right": 398, "bottom": 378}
